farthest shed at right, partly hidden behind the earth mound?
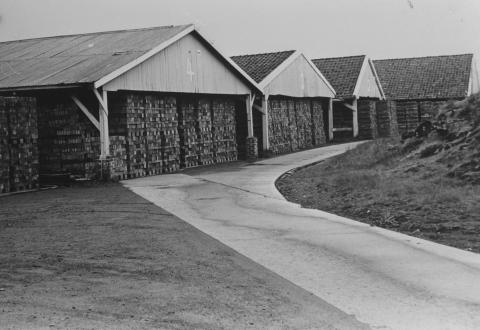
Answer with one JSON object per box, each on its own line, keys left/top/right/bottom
{"left": 374, "top": 54, "right": 479, "bottom": 134}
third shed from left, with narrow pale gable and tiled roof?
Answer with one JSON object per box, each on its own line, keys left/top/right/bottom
{"left": 312, "top": 55, "right": 384, "bottom": 140}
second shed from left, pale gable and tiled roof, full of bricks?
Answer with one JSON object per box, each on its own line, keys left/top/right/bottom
{"left": 232, "top": 50, "right": 335, "bottom": 155}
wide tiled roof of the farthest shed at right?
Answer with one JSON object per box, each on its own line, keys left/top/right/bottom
{"left": 374, "top": 54, "right": 473, "bottom": 100}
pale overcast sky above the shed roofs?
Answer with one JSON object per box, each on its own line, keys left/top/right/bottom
{"left": 0, "top": 0, "right": 480, "bottom": 60}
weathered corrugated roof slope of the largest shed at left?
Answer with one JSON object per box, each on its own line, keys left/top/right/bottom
{"left": 0, "top": 25, "right": 191, "bottom": 88}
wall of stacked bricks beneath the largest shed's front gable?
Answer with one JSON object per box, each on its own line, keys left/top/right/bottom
{"left": 110, "top": 92, "right": 237, "bottom": 177}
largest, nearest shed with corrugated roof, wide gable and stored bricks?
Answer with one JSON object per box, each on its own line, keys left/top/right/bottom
{"left": 0, "top": 25, "right": 259, "bottom": 188}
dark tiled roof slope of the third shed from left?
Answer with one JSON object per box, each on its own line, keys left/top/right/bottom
{"left": 312, "top": 55, "right": 366, "bottom": 99}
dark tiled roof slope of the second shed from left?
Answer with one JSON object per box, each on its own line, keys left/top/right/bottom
{"left": 232, "top": 50, "right": 295, "bottom": 83}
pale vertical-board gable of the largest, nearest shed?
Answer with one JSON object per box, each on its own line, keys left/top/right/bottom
{"left": 104, "top": 34, "right": 250, "bottom": 95}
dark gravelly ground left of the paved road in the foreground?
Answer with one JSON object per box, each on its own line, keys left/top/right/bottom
{"left": 0, "top": 184, "right": 364, "bottom": 329}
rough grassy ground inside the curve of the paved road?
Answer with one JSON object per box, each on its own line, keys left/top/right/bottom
{"left": 276, "top": 140, "right": 480, "bottom": 252}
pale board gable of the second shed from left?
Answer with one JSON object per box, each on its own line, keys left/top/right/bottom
{"left": 265, "top": 55, "right": 333, "bottom": 97}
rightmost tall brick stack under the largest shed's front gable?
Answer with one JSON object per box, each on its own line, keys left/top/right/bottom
{"left": 212, "top": 100, "right": 238, "bottom": 163}
